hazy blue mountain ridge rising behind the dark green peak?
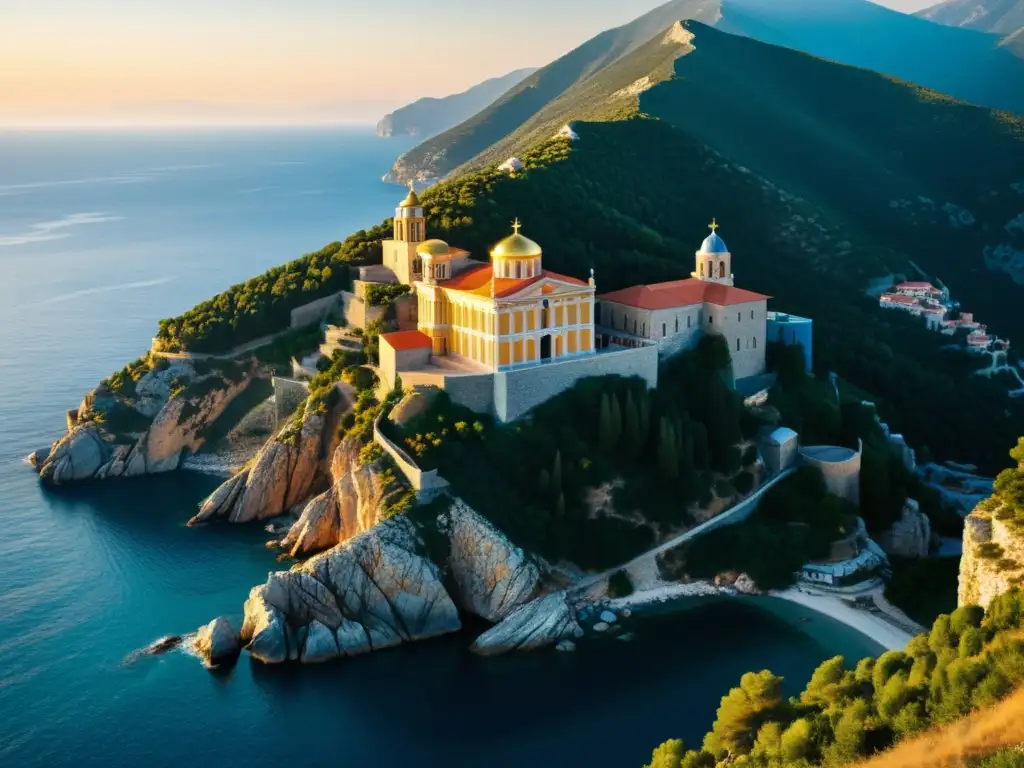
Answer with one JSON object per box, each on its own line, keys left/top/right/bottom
{"left": 390, "top": 0, "right": 1024, "bottom": 181}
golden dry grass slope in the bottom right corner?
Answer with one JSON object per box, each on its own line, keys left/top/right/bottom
{"left": 859, "top": 690, "right": 1024, "bottom": 768}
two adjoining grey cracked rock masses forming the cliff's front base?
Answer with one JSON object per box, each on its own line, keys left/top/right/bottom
{"left": 230, "top": 499, "right": 541, "bottom": 664}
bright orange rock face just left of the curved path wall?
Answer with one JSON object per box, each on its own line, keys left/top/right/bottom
{"left": 281, "top": 437, "right": 387, "bottom": 557}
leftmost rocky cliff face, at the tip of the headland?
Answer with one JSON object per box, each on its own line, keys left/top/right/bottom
{"left": 37, "top": 361, "right": 251, "bottom": 484}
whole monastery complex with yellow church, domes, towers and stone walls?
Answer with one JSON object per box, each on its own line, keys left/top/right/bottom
{"left": 380, "top": 189, "right": 806, "bottom": 422}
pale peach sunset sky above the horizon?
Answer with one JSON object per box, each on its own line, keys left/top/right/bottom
{"left": 0, "top": 0, "right": 931, "bottom": 126}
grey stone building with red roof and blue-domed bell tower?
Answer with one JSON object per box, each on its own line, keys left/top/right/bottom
{"left": 598, "top": 223, "right": 771, "bottom": 379}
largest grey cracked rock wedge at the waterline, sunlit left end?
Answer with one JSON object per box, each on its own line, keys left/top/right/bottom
{"left": 235, "top": 517, "right": 461, "bottom": 664}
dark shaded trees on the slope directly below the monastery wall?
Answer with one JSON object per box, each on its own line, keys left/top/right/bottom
{"left": 394, "top": 337, "right": 757, "bottom": 568}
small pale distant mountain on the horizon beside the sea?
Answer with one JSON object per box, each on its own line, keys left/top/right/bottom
{"left": 377, "top": 68, "right": 537, "bottom": 138}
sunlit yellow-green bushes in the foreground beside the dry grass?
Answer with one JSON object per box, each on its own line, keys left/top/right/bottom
{"left": 649, "top": 590, "right": 1024, "bottom": 768}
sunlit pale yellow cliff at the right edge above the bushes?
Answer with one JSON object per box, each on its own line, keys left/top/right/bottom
{"left": 957, "top": 504, "right": 1024, "bottom": 607}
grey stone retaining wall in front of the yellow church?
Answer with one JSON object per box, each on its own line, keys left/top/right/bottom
{"left": 494, "top": 346, "right": 657, "bottom": 422}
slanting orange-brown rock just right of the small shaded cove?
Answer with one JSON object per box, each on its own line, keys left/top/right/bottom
{"left": 188, "top": 413, "right": 325, "bottom": 525}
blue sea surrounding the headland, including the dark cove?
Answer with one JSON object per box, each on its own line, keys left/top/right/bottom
{"left": 0, "top": 126, "right": 881, "bottom": 768}
